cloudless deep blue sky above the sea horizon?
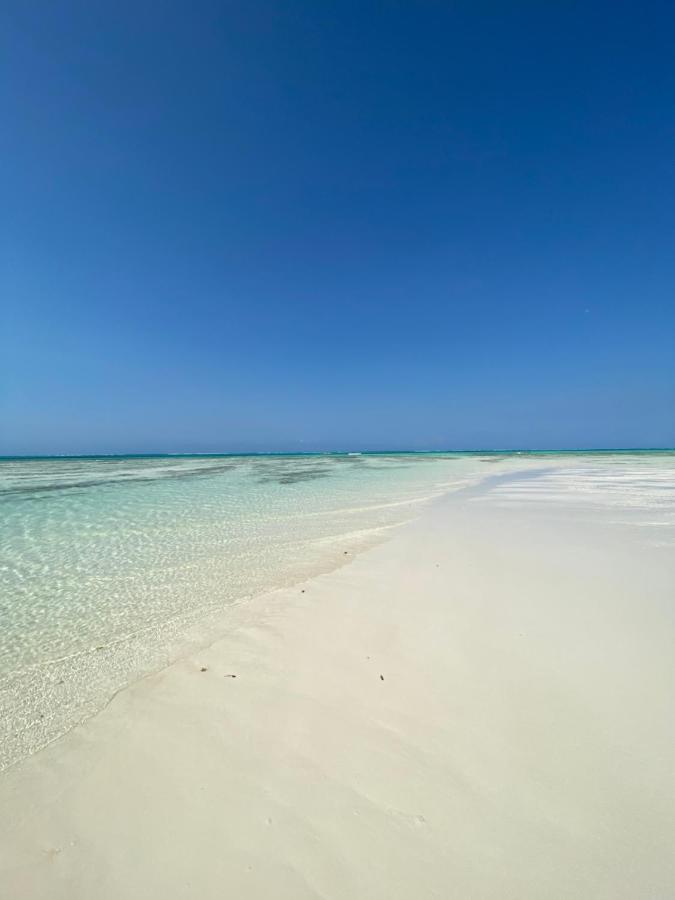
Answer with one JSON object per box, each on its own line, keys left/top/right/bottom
{"left": 0, "top": 0, "right": 675, "bottom": 455}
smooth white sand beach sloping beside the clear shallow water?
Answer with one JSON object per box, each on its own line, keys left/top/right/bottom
{"left": 0, "top": 467, "right": 675, "bottom": 900}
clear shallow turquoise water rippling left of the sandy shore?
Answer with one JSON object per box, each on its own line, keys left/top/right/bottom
{"left": 0, "top": 455, "right": 485, "bottom": 767}
